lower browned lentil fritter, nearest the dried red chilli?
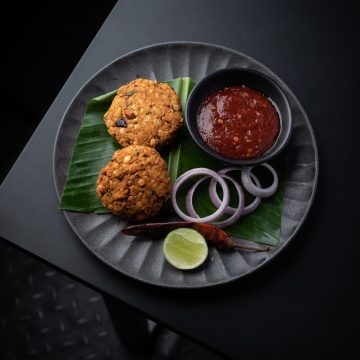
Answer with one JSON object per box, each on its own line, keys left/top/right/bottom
{"left": 96, "top": 145, "right": 171, "bottom": 221}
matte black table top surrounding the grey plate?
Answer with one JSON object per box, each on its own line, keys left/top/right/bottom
{"left": 0, "top": 0, "right": 360, "bottom": 359}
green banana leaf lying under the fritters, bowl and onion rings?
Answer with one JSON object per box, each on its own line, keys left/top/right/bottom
{"left": 60, "top": 78, "right": 286, "bottom": 246}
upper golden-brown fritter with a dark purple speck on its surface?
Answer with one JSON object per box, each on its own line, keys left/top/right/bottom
{"left": 104, "top": 79, "right": 184, "bottom": 149}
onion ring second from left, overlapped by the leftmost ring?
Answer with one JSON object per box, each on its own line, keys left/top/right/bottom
{"left": 186, "top": 174, "right": 245, "bottom": 227}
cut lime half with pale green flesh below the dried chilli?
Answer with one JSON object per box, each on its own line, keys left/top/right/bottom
{"left": 163, "top": 228, "right": 208, "bottom": 270}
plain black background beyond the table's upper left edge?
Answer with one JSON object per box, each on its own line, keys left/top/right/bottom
{"left": 0, "top": 0, "right": 116, "bottom": 183}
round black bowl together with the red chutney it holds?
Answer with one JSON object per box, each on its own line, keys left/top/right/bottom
{"left": 186, "top": 68, "right": 292, "bottom": 165}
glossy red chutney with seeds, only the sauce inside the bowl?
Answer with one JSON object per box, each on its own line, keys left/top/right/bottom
{"left": 197, "top": 86, "right": 280, "bottom": 159}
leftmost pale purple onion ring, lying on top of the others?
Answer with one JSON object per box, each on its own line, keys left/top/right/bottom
{"left": 171, "top": 168, "right": 230, "bottom": 223}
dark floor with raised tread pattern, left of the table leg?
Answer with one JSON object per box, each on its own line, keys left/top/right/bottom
{"left": 0, "top": 243, "right": 132, "bottom": 360}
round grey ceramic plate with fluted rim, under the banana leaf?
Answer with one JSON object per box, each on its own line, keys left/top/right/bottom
{"left": 54, "top": 42, "right": 318, "bottom": 288}
